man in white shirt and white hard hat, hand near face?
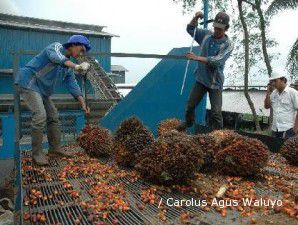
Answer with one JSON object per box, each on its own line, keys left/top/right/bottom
{"left": 265, "top": 72, "right": 298, "bottom": 139}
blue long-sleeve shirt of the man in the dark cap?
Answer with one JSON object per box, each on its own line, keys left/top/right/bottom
{"left": 186, "top": 24, "right": 233, "bottom": 90}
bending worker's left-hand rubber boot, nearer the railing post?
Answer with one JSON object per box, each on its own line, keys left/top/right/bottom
{"left": 32, "top": 130, "right": 49, "bottom": 166}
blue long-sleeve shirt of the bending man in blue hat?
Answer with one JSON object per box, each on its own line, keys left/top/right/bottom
{"left": 15, "top": 42, "right": 82, "bottom": 98}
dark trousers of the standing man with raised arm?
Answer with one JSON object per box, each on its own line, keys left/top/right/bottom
{"left": 185, "top": 82, "right": 223, "bottom": 130}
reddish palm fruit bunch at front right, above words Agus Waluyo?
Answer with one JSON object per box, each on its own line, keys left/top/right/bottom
{"left": 214, "top": 135, "right": 269, "bottom": 176}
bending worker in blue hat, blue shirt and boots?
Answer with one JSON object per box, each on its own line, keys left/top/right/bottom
{"left": 15, "top": 35, "right": 91, "bottom": 165}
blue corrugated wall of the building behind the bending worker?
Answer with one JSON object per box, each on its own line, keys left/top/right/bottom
{"left": 0, "top": 27, "right": 111, "bottom": 94}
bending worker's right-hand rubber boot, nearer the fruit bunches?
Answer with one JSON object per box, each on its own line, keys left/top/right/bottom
{"left": 47, "top": 125, "right": 71, "bottom": 157}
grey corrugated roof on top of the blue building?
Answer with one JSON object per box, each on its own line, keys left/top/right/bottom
{"left": 0, "top": 13, "right": 117, "bottom": 37}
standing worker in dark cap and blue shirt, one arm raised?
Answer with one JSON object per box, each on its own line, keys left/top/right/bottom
{"left": 178, "top": 12, "right": 233, "bottom": 130}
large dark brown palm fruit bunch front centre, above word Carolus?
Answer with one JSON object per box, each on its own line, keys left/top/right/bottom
{"left": 136, "top": 130, "right": 203, "bottom": 185}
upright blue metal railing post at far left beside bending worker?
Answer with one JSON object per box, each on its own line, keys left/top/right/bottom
{"left": 13, "top": 54, "right": 23, "bottom": 224}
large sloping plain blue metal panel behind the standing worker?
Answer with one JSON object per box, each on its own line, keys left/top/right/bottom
{"left": 100, "top": 48, "right": 206, "bottom": 134}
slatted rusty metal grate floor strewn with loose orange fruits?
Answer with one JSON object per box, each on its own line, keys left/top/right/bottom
{"left": 22, "top": 149, "right": 298, "bottom": 225}
